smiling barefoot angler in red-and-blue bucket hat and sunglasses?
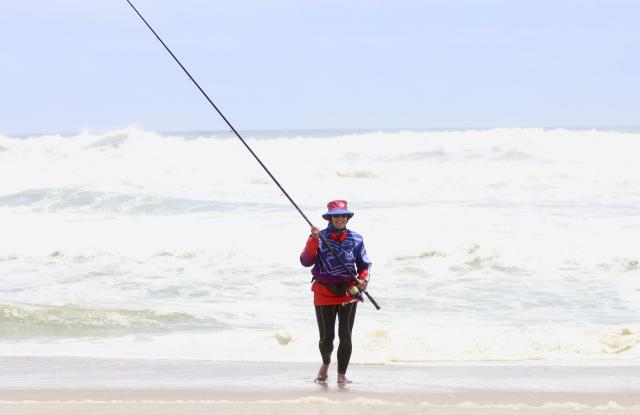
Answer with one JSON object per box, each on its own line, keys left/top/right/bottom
{"left": 300, "top": 200, "right": 371, "bottom": 384}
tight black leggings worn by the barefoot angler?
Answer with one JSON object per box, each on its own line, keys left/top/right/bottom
{"left": 315, "top": 303, "right": 358, "bottom": 375}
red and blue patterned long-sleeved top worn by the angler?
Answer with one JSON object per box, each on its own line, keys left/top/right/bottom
{"left": 300, "top": 224, "right": 371, "bottom": 305}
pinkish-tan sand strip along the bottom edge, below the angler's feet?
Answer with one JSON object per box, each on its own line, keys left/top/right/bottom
{"left": 0, "top": 389, "right": 640, "bottom": 415}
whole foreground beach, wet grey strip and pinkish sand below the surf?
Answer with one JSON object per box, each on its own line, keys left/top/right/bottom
{"left": 0, "top": 357, "right": 640, "bottom": 415}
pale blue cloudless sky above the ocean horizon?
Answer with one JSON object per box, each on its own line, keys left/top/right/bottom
{"left": 0, "top": 0, "right": 640, "bottom": 134}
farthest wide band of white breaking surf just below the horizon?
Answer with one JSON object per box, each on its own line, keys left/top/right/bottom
{"left": 0, "top": 128, "right": 640, "bottom": 210}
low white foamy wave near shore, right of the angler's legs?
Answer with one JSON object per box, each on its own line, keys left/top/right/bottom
{"left": 359, "top": 324, "right": 640, "bottom": 364}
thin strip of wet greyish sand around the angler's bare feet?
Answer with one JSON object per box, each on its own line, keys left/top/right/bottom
{"left": 0, "top": 356, "right": 640, "bottom": 394}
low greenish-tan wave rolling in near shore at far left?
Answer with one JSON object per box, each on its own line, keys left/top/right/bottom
{"left": 0, "top": 304, "right": 225, "bottom": 339}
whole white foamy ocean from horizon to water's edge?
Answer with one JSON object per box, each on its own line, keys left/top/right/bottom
{"left": 0, "top": 128, "right": 640, "bottom": 364}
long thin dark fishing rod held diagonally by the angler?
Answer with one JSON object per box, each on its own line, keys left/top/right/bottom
{"left": 125, "top": 0, "right": 380, "bottom": 310}
